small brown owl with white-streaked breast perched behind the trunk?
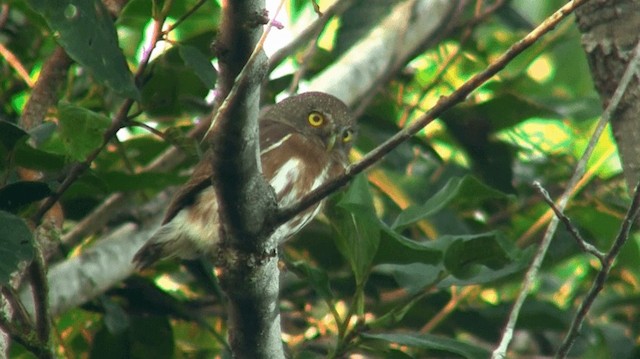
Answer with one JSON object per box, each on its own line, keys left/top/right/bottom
{"left": 133, "top": 92, "right": 355, "bottom": 269}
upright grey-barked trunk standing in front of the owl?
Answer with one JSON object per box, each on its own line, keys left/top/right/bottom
{"left": 205, "top": 0, "right": 284, "bottom": 358}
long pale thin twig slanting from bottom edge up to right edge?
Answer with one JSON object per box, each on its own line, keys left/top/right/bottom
{"left": 492, "top": 33, "right": 640, "bottom": 359}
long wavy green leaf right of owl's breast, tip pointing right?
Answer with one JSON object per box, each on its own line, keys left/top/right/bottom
{"left": 392, "top": 176, "right": 507, "bottom": 229}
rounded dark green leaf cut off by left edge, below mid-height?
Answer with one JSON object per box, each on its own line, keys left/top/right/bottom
{"left": 0, "top": 210, "right": 34, "bottom": 286}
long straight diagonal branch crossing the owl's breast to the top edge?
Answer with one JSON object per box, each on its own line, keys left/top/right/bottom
{"left": 274, "top": 0, "right": 587, "bottom": 230}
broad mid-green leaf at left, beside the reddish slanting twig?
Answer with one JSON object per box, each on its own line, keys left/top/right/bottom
{"left": 58, "top": 105, "right": 111, "bottom": 161}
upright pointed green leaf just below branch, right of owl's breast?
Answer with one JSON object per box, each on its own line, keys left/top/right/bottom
{"left": 328, "top": 175, "right": 382, "bottom": 284}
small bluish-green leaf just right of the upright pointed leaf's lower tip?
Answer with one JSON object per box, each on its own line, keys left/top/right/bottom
{"left": 374, "top": 263, "right": 442, "bottom": 295}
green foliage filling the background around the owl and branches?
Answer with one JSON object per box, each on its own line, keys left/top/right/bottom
{"left": 0, "top": 0, "right": 640, "bottom": 358}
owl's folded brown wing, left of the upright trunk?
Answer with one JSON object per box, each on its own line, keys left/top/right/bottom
{"left": 162, "top": 151, "right": 213, "bottom": 224}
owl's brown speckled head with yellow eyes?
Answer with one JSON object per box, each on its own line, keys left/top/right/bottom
{"left": 265, "top": 92, "right": 356, "bottom": 157}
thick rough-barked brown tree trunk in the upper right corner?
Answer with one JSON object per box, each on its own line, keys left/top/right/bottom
{"left": 576, "top": 0, "right": 640, "bottom": 190}
